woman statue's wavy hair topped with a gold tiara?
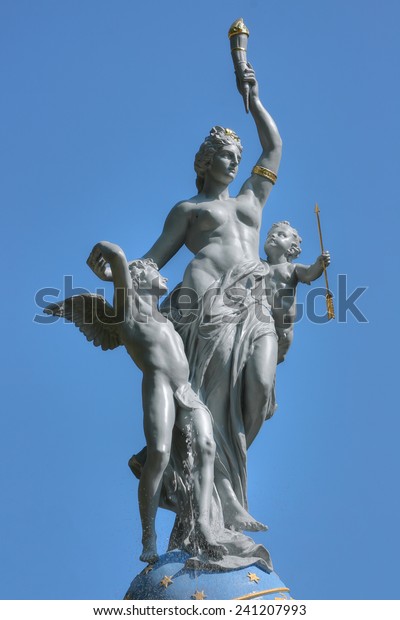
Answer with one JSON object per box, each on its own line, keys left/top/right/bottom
{"left": 194, "top": 125, "right": 243, "bottom": 192}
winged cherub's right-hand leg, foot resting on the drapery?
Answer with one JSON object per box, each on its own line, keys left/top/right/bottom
{"left": 176, "top": 407, "right": 227, "bottom": 559}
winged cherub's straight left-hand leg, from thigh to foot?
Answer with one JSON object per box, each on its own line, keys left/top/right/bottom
{"left": 139, "top": 375, "right": 175, "bottom": 562}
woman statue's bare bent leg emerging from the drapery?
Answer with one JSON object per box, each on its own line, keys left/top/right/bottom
{"left": 243, "top": 333, "right": 278, "bottom": 448}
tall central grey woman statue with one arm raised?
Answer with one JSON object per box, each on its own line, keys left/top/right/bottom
{"left": 145, "top": 67, "right": 282, "bottom": 530}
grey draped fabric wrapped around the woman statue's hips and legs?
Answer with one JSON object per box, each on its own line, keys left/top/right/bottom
{"left": 161, "top": 261, "right": 276, "bottom": 570}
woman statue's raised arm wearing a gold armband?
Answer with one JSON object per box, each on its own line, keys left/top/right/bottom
{"left": 239, "top": 63, "right": 282, "bottom": 207}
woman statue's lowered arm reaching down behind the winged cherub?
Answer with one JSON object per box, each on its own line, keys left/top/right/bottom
{"left": 143, "top": 202, "right": 190, "bottom": 269}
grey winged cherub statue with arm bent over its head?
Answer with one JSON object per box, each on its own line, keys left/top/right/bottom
{"left": 45, "top": 241, "right": 227, "bottom": 563}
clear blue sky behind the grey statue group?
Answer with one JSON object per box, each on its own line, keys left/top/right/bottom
{"left": 0, "top": 0, "right": 400, "bottom": 599}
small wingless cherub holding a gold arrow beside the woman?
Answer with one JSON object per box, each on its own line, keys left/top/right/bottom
{"left": 264, "top": 221, "right": 333, "bottom": 364}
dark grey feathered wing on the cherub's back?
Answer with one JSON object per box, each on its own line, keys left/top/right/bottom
{"left": 43, "top": 293, "right": 122, "bottom": 351}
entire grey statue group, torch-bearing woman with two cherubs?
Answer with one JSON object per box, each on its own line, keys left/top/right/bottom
{"left": 43, "top": 19, "right": 330, "bottom": 598}
